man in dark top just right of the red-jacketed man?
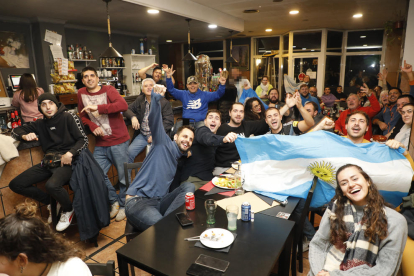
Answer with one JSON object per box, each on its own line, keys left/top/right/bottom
{"left": 372, "top": 87, "right": 402, "bottom": 135}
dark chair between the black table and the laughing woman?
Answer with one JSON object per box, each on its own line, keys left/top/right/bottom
{"left": 291, "top": 176, "right": 318, "bottom": 276}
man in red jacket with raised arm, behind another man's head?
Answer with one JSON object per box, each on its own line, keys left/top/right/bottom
{"left": 335, "top": 84, "right": 381, "bottom": 140}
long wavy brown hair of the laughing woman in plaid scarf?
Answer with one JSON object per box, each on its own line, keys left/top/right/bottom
{"left": 330, "top": 164, "right": 389, "bottom": 244}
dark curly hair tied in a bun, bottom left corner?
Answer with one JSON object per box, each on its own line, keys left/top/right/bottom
{"left": 0, "top": 200, "right": 82, "bottom": 263}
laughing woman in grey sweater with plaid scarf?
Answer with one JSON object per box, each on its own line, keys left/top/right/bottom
{"left": 308, "top": 164, "right": 408, "bottom": 276}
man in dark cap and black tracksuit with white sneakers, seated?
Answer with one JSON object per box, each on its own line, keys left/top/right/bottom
{"left": 9, "top": 93, "right": 88, "bottom": 231}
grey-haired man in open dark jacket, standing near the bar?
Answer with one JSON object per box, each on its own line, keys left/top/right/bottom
{"left": 124, "top": 78, "right": 174, "bottom": 163}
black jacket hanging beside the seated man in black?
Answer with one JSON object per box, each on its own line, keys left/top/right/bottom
{"left": 70, "top": 148, "right": 110, "bottom": 241}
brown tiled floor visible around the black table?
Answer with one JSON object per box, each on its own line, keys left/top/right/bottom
{"left": 58, "top": 216, "right": 319, "bottom": 276}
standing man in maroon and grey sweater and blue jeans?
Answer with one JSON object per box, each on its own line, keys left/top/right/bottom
{"left": 78, "top": 67, "right": 129, "bottom": 221}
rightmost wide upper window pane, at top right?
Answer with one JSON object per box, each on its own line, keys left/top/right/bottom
{"left": 346, "top": 30, "right": 384, "bottom": 52}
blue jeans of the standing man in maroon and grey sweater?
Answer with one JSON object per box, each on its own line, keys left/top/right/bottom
{"left": 93, "top": 141, "right": 129, "bottom": 208}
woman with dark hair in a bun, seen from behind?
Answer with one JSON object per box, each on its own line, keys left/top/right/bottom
{"left": 0, "top": 200, "right": 92, "bottom": 276}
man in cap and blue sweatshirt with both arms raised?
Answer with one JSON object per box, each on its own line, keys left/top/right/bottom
{"left": 163, "top": 65, "right": 226, "bottom": 128}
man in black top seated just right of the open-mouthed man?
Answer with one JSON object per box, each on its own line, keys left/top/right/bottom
{"left": 213, "top": 103, "right": 269, "bottom": 175}
